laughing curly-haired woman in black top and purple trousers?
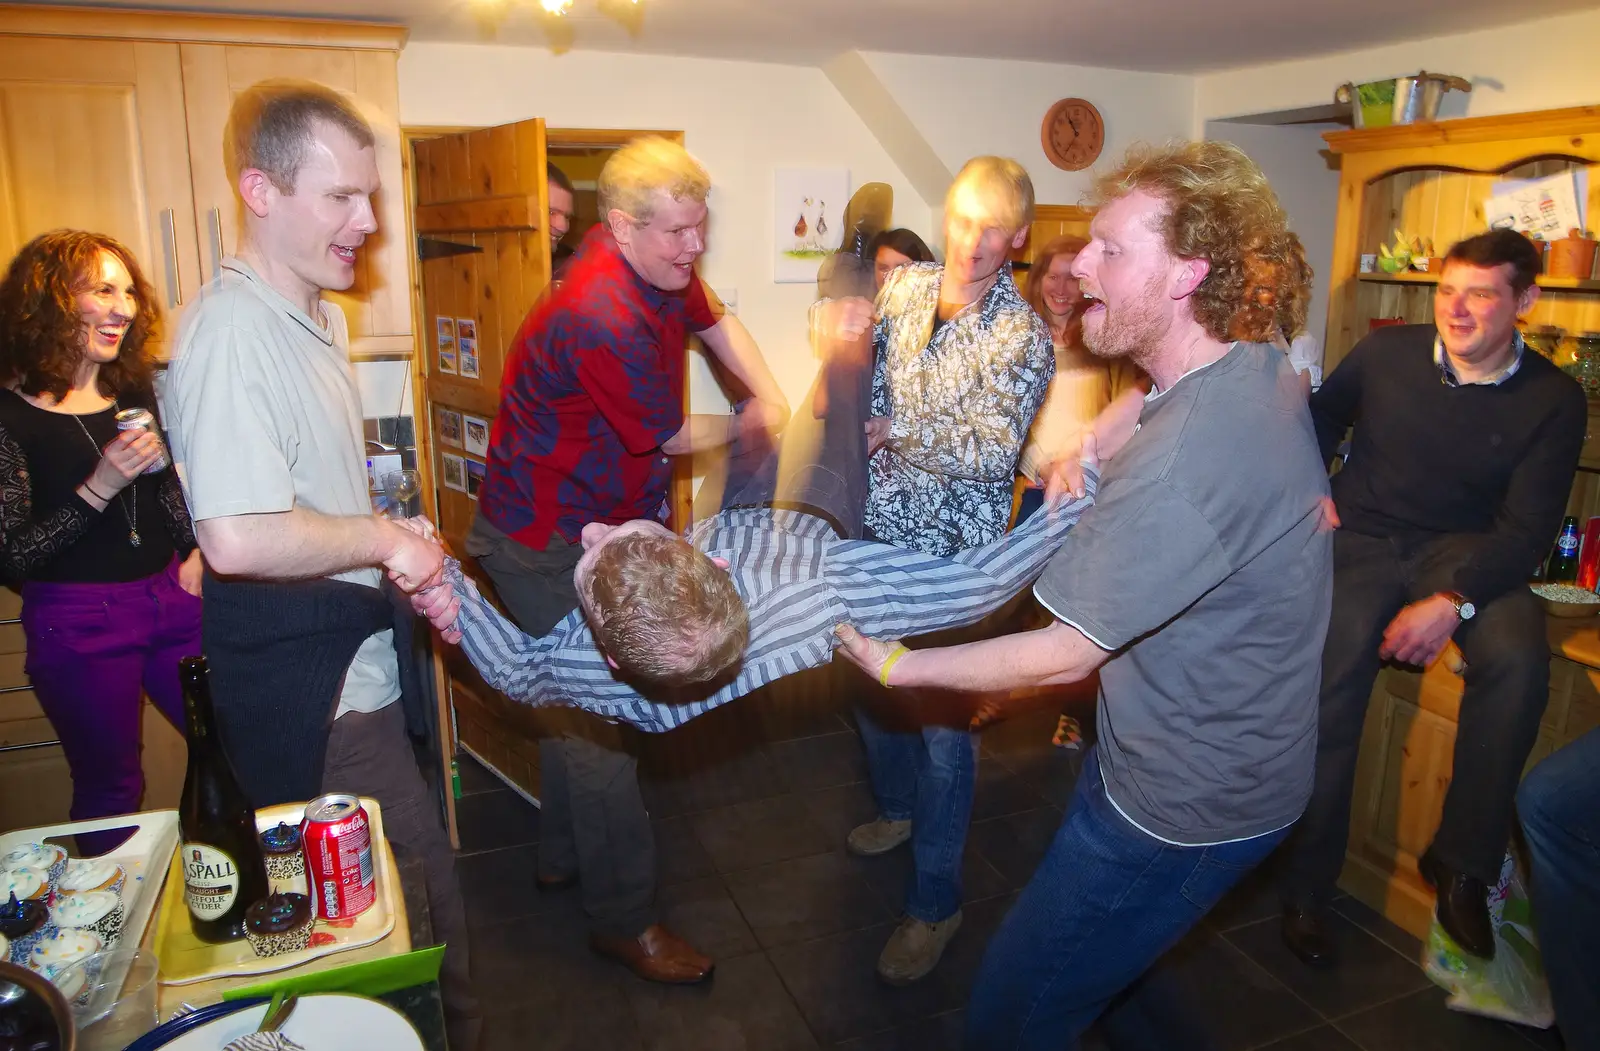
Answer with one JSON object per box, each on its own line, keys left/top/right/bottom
{"left": 0, "top": 230, "right": 200, "bottom": 825}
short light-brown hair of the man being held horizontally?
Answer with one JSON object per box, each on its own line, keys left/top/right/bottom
{"left": 586, "top": 533, "right": 750, "bottom": 686}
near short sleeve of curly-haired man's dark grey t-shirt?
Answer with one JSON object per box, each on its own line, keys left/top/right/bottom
{"left": 1034, "top": 478, "right": 1232, "bottom": 651}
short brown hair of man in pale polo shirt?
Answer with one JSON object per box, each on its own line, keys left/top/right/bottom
{"left": 222, "top": 80, "right": 378, "bottom": 194}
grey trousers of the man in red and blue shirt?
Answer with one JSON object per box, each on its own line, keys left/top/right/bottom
{"left": 466, "top": 515, "right": 658, "bottom": 937}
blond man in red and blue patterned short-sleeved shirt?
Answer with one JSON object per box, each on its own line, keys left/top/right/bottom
{"left": 466, "top": 138, "right": 789, "bottom": 982}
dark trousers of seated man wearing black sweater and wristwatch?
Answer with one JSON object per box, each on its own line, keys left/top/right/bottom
{"left": 1280, "top": 529, "right": 1550, "bottom": 905}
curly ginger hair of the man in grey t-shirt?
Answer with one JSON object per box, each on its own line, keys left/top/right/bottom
{"left": 1093, "top": 141, "right": 1312, "bottom": 342}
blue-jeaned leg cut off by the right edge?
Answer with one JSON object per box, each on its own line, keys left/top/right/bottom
{"left": 1517, "top": 729, "right": 1600, "bottom": 1051}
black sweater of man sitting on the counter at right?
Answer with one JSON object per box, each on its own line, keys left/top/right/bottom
{"left": 1310, "top": 325, "right": 1589, "bottom": 606}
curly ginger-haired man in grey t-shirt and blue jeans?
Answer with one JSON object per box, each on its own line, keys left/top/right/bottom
{"left": 840, "top": 142, "right": 1333, "bottom": 1051}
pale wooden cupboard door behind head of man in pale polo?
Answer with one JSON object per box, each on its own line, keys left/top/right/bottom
{"left": 182, "top": 43, "right": 413, "bottom": 358}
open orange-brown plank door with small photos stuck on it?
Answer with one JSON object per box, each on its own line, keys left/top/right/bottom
{"left": 413, "top": 120, "right": 550, "bottom": 797}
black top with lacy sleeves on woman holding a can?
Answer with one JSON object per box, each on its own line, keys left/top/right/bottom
{"left": 0, "top": 390, "right": 195, "bottom": 584}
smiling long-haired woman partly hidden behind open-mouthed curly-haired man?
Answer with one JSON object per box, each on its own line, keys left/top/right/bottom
{"left": 1016, "top": 237, "right": 1149, "bottom": 522}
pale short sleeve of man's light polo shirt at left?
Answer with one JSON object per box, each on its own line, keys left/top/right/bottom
{"left": 166, "top": 325, "right": 294, "bottom": 522}
